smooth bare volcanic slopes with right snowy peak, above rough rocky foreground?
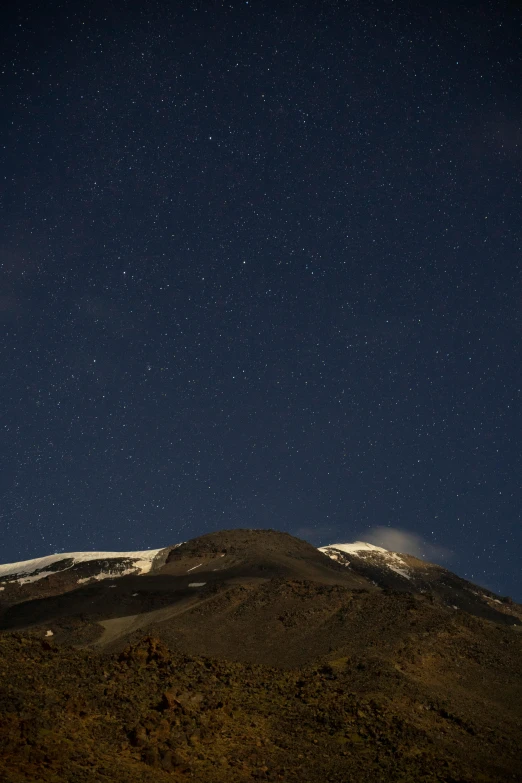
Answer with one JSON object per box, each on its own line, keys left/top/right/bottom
{"left": 0, "top": 530, "right": 521, "bottom": 667}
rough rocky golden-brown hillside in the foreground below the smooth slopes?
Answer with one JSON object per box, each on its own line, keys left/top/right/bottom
{"left": 0, "top": 616, "right": 522, "bottom": 783}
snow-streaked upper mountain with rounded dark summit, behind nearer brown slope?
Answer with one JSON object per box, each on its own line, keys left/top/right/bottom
{"left": 0, "top": 529, "right": 522, "bottom": 641}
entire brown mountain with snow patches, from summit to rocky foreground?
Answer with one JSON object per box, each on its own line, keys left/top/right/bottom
{"left": 0, "top": 530, "right": 522, "bottom": 783}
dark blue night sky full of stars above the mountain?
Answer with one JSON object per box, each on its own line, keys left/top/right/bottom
{"left": 0, "top": 0, "right": 522, "bottom": 600}
